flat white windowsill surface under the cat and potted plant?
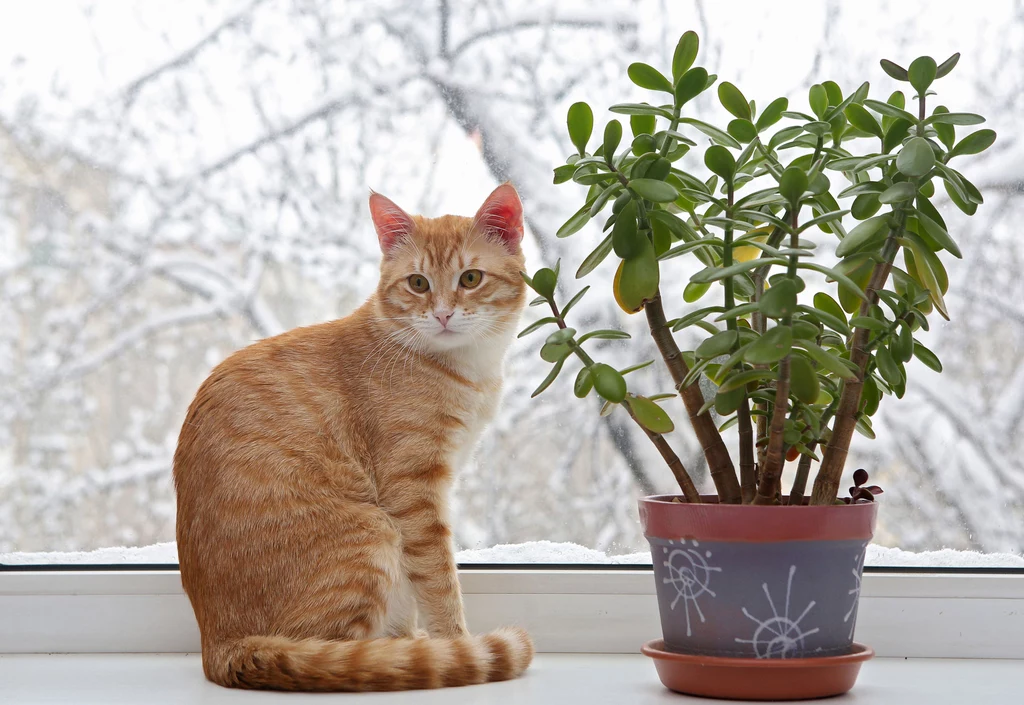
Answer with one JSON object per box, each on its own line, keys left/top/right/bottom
{"left": 0, "top": 654, "right": 1024, "bottom": 705}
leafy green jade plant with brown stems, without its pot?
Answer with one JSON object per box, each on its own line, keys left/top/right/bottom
{"left": 520, "top": 32, "right": 995, "bottom": 504}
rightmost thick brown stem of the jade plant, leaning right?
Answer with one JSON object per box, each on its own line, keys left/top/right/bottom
{"left": 810, "top": 231, "right": 903, "bottom": 504}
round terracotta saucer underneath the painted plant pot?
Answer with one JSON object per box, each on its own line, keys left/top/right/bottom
{"left": 640, "top": 639, "right": 874, "bottom": 700}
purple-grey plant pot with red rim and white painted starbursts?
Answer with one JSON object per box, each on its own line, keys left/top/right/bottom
{"left": 640, "top": 495, "right": 878, "bottom": 658}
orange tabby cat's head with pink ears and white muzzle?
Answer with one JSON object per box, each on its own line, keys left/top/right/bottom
{"left": 370, "top": 183, "right": 526, "bottom": 350}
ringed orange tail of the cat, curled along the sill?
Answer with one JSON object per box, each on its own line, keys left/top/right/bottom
{"left": 203, "top": 627, "right": 534, "bottom": 691}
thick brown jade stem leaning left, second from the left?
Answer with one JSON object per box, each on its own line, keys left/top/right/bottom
{"left": 644, "top": 291, "right": 741, "bottom": 504}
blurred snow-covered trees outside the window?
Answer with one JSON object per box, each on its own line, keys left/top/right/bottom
{"left": 0, "top": 0, "right": 1024, "bottom": 561}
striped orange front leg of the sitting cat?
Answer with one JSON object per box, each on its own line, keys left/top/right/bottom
{"left": 389, "top": 487, "right": 468, "bottom": 637}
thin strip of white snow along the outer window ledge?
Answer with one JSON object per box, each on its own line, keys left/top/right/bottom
{"left": 0, "top": 541, "right": 1024, "bottom": 568}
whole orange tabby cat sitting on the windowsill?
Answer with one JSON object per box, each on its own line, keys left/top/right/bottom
{"left": 174, "top": 184, "right": 534, "bottom": 691}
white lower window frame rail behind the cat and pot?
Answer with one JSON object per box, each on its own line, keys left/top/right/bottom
{"left": 0, "top": 565, "right": 1024, "bottom": 659}
